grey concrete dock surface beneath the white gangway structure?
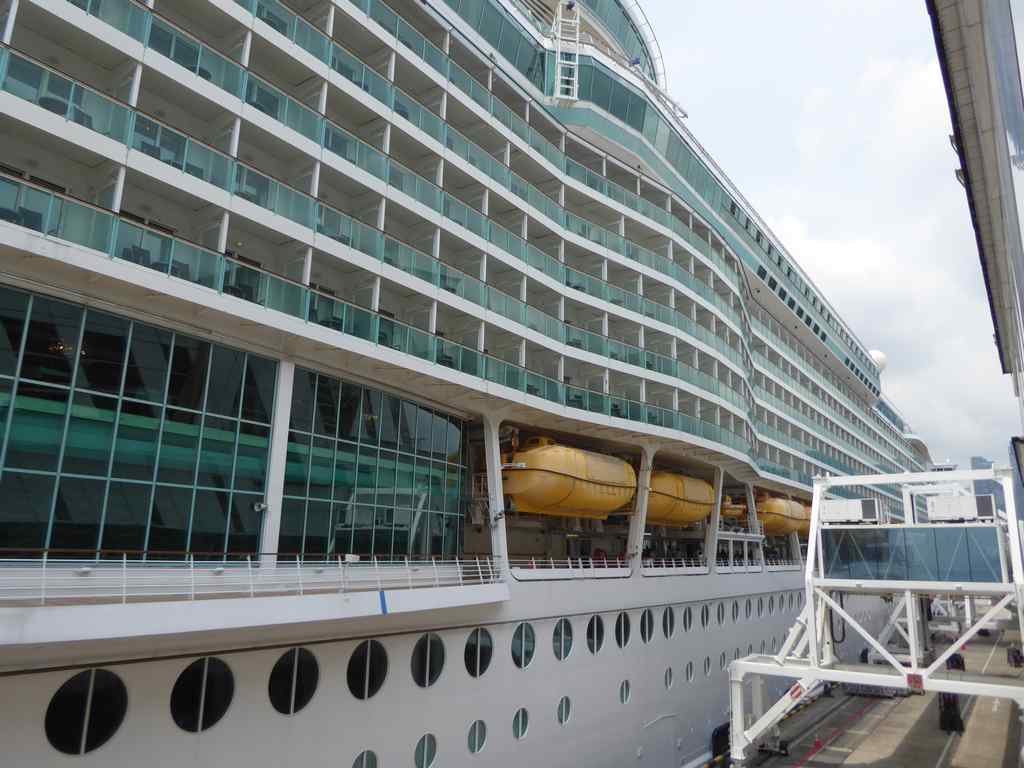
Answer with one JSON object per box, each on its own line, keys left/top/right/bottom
{"left": 756, "top": 632, "right": 1024, "bottom": 768}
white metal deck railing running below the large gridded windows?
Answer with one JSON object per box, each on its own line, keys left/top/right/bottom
{"left": 0, "top": 556, "right": 503, "bottom": 605}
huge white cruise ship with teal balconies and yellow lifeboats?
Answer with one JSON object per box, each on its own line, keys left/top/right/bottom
{"left": 0, "top": 0, "right": 930, "bottom": 768}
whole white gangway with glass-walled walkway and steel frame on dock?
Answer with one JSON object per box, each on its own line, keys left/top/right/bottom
{"left": 729, "top": 469, "right": 1024, "bottom": 765}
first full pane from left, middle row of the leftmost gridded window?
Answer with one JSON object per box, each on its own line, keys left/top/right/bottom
{"left": 5, "top": 382, "right": 69, "bottom": 471}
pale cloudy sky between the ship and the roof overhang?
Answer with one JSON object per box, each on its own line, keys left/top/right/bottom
{"left": 642, "top": 0, "right": 1020, "bottom": 467}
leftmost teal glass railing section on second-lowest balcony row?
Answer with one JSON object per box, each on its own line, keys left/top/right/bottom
{"left": 0, "top": 53, "right": 131, "bottom": 143}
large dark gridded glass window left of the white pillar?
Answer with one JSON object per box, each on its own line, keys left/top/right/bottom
{"left": 0, "top": 288, "right": 276, "bottom": 559}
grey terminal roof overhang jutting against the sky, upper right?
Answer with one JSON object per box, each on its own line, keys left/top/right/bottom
{"left": 927, "top": 0, "right": 1016, "bottom": 373}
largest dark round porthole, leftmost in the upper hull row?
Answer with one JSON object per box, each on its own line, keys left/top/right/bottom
{"left": 43, "top": 670, "right": 128, "bottom": 755}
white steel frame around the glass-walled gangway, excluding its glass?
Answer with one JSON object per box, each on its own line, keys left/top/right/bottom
{"left": 729, "top": 468, "right": 1024, "bottom": 766}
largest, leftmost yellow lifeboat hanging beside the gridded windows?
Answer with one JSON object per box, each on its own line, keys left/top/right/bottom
{"left": 502, "top": 437, "right": 637, "bottom": 520}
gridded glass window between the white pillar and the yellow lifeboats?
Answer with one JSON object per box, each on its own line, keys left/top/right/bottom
{"left": 279, "top": 370, "right": 466, "bottom": 559}
